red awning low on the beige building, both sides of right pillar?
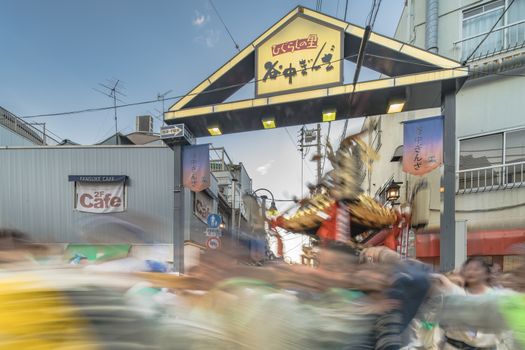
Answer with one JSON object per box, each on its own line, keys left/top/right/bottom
{"left": 416, "top": 228, "right": 525, "bottom": 258}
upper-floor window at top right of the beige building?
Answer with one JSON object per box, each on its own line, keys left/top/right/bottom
{"left": 462, "top": 0, "right": 525, "bottom": 59}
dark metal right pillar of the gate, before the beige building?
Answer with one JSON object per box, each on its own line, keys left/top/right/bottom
{"left": 439, "top": 91, "right": 458, "bottom": 271}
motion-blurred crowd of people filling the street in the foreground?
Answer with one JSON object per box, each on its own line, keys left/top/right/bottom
{"left": 0, "top": 230, "right": 525, "bottom": 350}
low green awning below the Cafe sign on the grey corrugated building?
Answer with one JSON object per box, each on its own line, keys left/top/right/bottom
{"left": 64, "top": 243, "right": 131, "bottom": 261}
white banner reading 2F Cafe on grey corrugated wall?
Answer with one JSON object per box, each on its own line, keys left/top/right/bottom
{"left": 75, "top": 181, "right": 126, "bottom": 214}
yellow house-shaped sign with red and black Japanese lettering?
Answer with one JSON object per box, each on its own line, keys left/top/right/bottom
{"left": 255, "top": 16, "right": 343, "bottom": 96}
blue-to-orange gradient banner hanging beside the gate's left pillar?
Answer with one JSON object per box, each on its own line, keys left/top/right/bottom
{"left": 182, "top": 144, "right": 210, "bottom": 192}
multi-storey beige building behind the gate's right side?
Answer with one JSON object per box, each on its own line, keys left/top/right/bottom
{"left": 364, "top": 0, "right": 525, "bottom": 269}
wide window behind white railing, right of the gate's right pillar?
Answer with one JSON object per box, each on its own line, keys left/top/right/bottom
{"left": 459, "top": 129, "right": 525, "bottom": 191}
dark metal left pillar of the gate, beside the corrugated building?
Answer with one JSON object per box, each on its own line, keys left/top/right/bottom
{"left": 172, "top": 145, "right": 184, "bottom": 273}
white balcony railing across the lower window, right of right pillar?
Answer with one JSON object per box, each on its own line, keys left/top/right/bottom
{"left": 456, "top": 162, "right": 525, "bottom": 194}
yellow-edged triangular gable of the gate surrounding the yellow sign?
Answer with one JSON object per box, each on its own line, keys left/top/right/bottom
{"left": 165, "top": 6, "right": 461, "bottom": 115}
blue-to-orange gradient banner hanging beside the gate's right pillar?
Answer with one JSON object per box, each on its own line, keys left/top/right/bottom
{"left": 403, "top": 116, "right": 443, "bottom": 175}
